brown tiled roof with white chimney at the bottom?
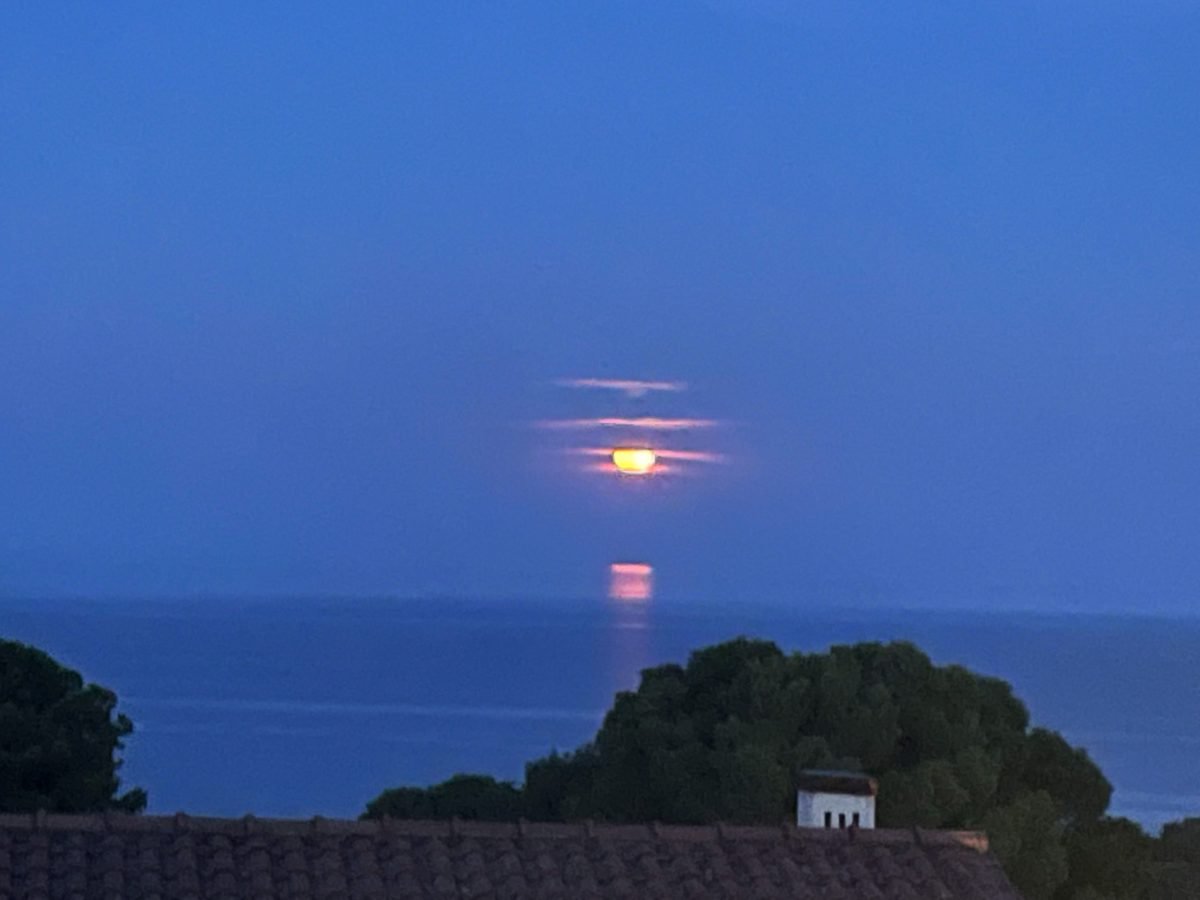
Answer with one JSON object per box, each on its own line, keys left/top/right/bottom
{"left": 0, "top": 814, "right": 1019, "bottom": 900}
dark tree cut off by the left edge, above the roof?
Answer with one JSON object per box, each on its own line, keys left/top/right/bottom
{"left": 0, "top": 640, "right": 146, "bottom": 812}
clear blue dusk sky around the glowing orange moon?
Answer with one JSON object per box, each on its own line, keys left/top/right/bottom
{"left": 0, "top": 0, "right": 1200, "bottom": 614}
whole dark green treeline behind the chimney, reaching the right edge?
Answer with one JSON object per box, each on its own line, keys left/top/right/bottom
{"left": 365, "top": 638, "right": 1200, "bottom": 900}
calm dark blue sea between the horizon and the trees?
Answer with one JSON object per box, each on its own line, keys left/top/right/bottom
{"left": 0, "top": 600, "right": 1200, "bottom": 828}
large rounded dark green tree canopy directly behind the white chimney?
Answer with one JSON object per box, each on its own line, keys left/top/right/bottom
{"left": 526, "top": 638, "right": 1111, "bottom": 844}
